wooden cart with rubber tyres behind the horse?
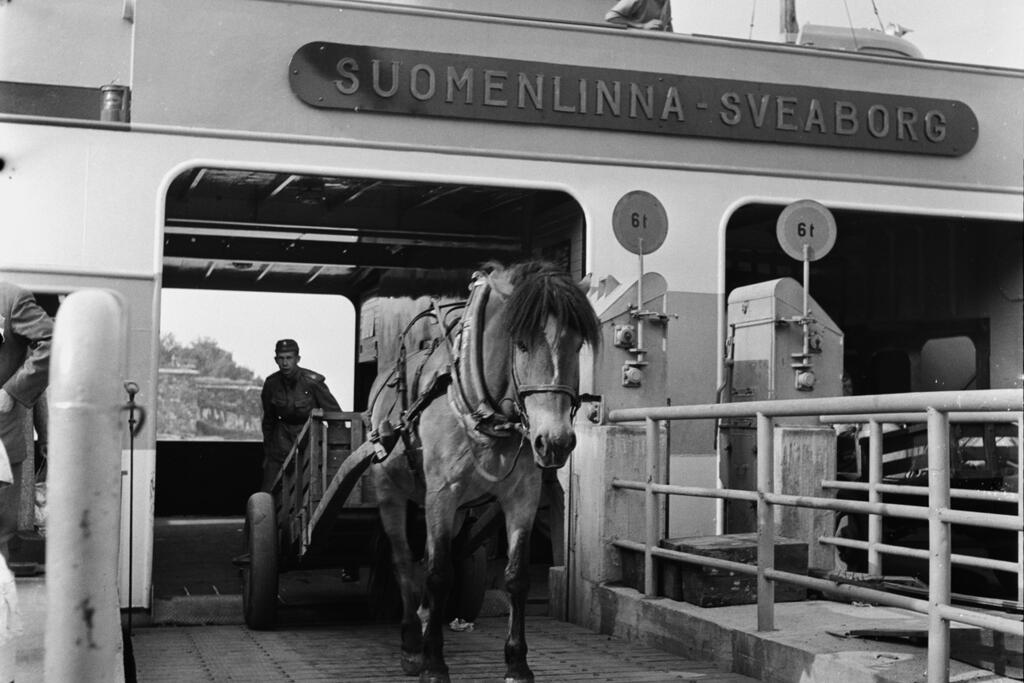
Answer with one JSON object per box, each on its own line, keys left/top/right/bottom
{"left": 240, "top": 410, "right": 499, "bottom": 630}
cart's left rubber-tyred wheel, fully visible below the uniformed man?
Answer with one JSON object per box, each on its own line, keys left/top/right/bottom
{"left": 242, "top": 492, "right": 278, "bottom": 630}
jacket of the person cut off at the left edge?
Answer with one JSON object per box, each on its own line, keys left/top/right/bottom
{"left": 0, "top": 282, "right": 53, "bottom": 463}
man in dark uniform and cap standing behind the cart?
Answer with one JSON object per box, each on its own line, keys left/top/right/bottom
{"left": 260, "top": 339, "right": 341, "bottom": 492}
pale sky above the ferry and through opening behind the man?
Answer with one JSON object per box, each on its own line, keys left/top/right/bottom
{"left": 161, "top": 0, "right": 1024, "bottom": 409}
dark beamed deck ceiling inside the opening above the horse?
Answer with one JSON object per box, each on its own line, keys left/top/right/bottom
{"left": 163, "top": 168, "right": 569, "bottom": 296}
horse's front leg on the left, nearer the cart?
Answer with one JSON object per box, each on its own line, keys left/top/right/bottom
{"left": 420, "top": 488, "right": 456, "bottom": 683}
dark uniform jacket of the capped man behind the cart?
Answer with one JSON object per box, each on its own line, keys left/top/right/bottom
{"left": 260, "top": 368, "right": 341, "bottom": 461}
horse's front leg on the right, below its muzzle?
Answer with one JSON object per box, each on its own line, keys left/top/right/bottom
{"left": 503, "top": 481, "right": 540, "bottom": 683}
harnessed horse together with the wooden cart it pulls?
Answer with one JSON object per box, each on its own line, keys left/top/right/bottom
{"left": 243, "top": 261, "right": 601, "bottom": 683}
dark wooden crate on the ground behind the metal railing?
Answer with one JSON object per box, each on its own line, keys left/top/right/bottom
{"left": 659, "top": 533, "right": 807, "bottom": 607}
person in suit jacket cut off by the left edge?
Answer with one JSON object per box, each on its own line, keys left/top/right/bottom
{"left": 0, "top": 282, "right": 53, "bottom": 558}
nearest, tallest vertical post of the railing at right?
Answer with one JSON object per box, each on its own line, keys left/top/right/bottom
{"left": 928, "top": 408, "right": 951, "bottom": 683}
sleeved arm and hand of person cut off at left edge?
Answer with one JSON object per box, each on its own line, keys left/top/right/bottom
{"left": 0, "top": 290, "right": 53, "bottom": 407}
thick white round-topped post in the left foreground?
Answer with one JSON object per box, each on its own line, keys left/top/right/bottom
{"left": 43, "top": 290, "right": 127, "bottom": 683}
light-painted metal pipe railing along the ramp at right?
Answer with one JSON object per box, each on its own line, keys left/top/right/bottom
{"left": 608, "top": 389, "right": 1024, "bottom": 683}
